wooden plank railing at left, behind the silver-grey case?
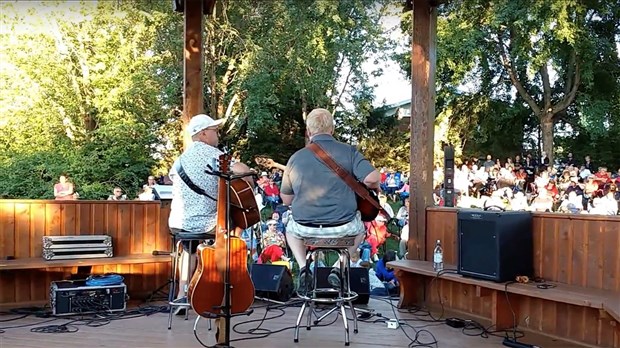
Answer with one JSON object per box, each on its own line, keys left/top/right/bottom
{"left": 0, "top": 200, "right": 170, "bottom": 304}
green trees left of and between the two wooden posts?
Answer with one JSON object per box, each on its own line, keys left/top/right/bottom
{"left": 0, "top": 0, "right": 389, "bottom": 199}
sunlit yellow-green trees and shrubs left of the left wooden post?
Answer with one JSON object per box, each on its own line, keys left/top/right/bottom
{"left": 0, "top": 2, "right": 179, "bottom": 199}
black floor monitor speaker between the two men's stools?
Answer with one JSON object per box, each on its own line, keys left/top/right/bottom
{"left": 251, "top": 264, "right": 295, "bottom": 302}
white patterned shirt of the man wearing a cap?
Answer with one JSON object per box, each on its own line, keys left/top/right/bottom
{"left": 168, "top": 141, "right": 222, "bottom": 233}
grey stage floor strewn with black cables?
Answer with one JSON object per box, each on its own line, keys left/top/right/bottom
{"left": 0, "top": 299, "right": 579, "bottom": 348}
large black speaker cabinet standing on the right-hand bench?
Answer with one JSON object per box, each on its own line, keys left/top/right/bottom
{"left": 458, "top": 209, "right": 534, "bottom": 282}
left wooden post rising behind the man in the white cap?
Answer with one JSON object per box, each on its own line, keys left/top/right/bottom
{"left": 183, "top": 0, "right": 204, "bottom": 148}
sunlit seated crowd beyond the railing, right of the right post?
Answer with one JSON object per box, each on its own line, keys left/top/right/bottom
{"left": 433, "top": 152, "right": 620, "bottom": 215}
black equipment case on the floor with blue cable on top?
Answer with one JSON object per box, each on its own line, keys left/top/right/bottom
{"left": 50, "top": 280, "right": 127, "bottom": 315}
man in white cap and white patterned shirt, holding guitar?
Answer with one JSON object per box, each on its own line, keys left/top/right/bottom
{"left": 168, "top": 114, "right": 253, "bottom": 315}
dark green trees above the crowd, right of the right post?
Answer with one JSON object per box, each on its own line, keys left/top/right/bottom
{"left": 396, "top": 0, "right": 620, "bottom": 164}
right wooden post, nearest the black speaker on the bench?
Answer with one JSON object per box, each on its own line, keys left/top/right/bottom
{"left": 408, "top": 0, "right": 437, "bottom": 260}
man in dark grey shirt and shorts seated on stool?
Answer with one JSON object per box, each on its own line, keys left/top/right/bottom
{"left": 280, "top": 109, "right": 381, "bottom": 289}
